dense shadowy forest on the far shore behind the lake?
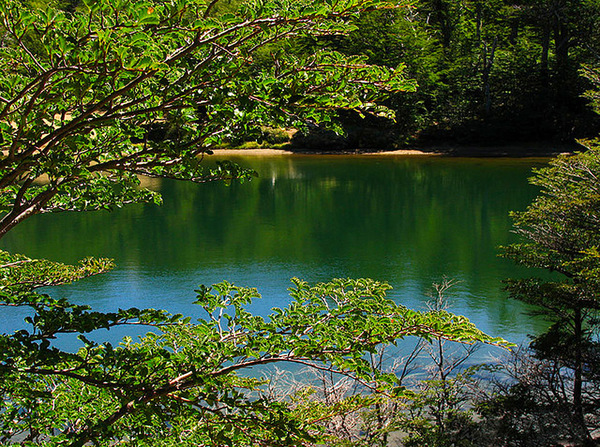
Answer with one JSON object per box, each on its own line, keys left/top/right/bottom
{"left": 270, "top": 0, "right": 600, "bottom": 153}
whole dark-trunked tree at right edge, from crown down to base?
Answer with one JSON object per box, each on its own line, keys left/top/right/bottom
{"left": 505, "top": 147, "right": 600, "bottom": 442}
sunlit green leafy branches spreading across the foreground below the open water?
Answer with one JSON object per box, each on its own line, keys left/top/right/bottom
{"left": 0, "top": 279, "right": 506, "bottom": 445}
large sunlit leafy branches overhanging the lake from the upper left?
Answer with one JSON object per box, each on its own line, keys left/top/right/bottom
{"left": 0, "top": 0, "right": 414, "bottom": 235}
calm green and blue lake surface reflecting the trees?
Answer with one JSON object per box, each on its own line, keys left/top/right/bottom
{"left": 0, "top": 155, "right": 547, "bottom": 352}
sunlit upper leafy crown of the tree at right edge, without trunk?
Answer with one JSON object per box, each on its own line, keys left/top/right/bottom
{"left": 505, "top": 147, "right": 600, "bottom": 308}
